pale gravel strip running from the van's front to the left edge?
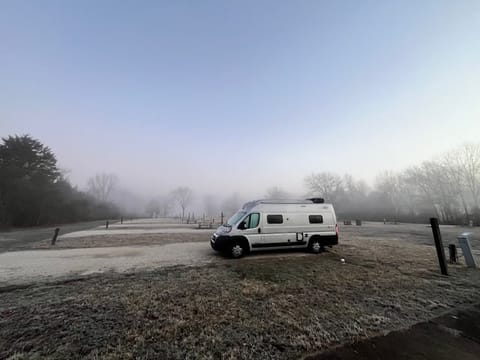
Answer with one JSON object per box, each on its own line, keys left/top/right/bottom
{"left": 0, "top": 242, "right": 214, "bottom": 285}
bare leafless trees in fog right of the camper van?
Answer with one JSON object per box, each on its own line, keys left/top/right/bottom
{"left": 305, "top": 144, "right": 480, "bottom": 226}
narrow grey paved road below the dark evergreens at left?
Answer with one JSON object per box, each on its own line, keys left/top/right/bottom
{"left": 0, "top": 220, "right": 105, "bottom": 253}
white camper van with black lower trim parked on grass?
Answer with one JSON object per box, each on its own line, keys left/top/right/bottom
{"left": 210, "top": 198, "right": 338, "bottom": 258}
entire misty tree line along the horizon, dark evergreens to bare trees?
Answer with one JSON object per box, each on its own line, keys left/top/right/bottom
{"left": 0, "top": 135, "right": 480, "bottom": 227}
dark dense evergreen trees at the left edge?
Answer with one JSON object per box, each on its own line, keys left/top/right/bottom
{"left": 0, "top": 135, "right": 119, "bottom": 227}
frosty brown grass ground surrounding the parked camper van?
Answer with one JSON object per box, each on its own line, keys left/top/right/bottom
{"left": 0, "top": 219, "right": 480, "bottom": 359}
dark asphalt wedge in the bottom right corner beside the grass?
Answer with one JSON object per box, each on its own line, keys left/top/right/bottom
{"left": 305, "top": 305, "right": 480, "bottom": 360}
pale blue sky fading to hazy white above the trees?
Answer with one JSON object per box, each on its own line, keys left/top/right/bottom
{"left": 0, "top": 0, "right": 480, "bottom": 196}
